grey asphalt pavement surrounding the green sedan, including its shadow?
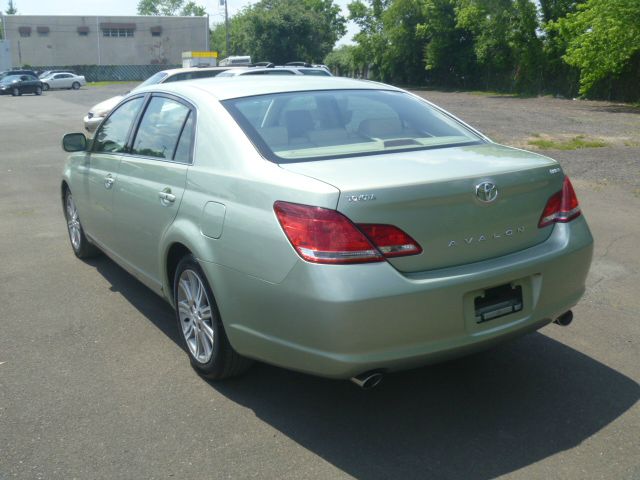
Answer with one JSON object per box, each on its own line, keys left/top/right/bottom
{"left": 0, "top": 85, "right": 640, "bottom": 480}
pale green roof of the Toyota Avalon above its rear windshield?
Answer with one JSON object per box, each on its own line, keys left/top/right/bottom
{"left": 136, "top": 75, "right": 402, "bottom": 100}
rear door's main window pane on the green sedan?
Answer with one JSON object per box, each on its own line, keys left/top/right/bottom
{"left": 131, "top": 97, "right": 190, "bottom": 163}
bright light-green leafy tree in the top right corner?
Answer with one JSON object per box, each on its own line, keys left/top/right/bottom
{"left": 550, "top": 0, "right": 640, "bottom": 95}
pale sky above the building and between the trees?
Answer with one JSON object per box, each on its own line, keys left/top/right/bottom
{"left": 0, "top": 0, "right": 358, "bottom": 45}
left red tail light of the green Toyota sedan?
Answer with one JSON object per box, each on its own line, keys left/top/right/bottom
{"left": 273, "top": 201, "right": 422, "bottom": 264}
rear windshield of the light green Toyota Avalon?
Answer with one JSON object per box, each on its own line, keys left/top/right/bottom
{"left": 222, "top": 90, "right": 482, "bottom": 163}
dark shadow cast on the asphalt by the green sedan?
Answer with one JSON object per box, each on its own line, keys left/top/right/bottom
{"left": 92, "top": 255, "right": 640, "bottom": 479}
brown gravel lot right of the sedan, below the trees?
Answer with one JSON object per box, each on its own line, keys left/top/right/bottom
{"left": 415, "top": 91, "right": 640, "bottom": 190}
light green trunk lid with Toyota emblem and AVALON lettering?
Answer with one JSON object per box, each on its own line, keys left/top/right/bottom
{"left": 281, "top": 144, "right": 563, "bottom": 273}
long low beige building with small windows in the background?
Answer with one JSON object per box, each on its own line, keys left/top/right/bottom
{"left": 3, "top": 15, "right": 209, "bottom": 66}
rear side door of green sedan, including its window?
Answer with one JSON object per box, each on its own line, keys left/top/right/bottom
{"left": 114, "top": 95, "right": 195, "bottom": 288}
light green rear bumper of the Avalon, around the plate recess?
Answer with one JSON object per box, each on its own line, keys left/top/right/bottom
{"left": 201, "top": 217, "right": 593, "bottom": 378}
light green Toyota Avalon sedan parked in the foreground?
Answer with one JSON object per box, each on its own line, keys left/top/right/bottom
{"left": 61, "top": 76, "right": 593, "bottom": 387}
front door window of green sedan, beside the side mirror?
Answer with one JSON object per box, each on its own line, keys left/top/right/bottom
{"left": 92, "top": 97, "right": 144, "bottom": 153}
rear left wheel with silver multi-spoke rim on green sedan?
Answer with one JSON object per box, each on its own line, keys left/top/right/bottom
{"left": 173, "top": 255, "right": 252, "bottom": 380}
